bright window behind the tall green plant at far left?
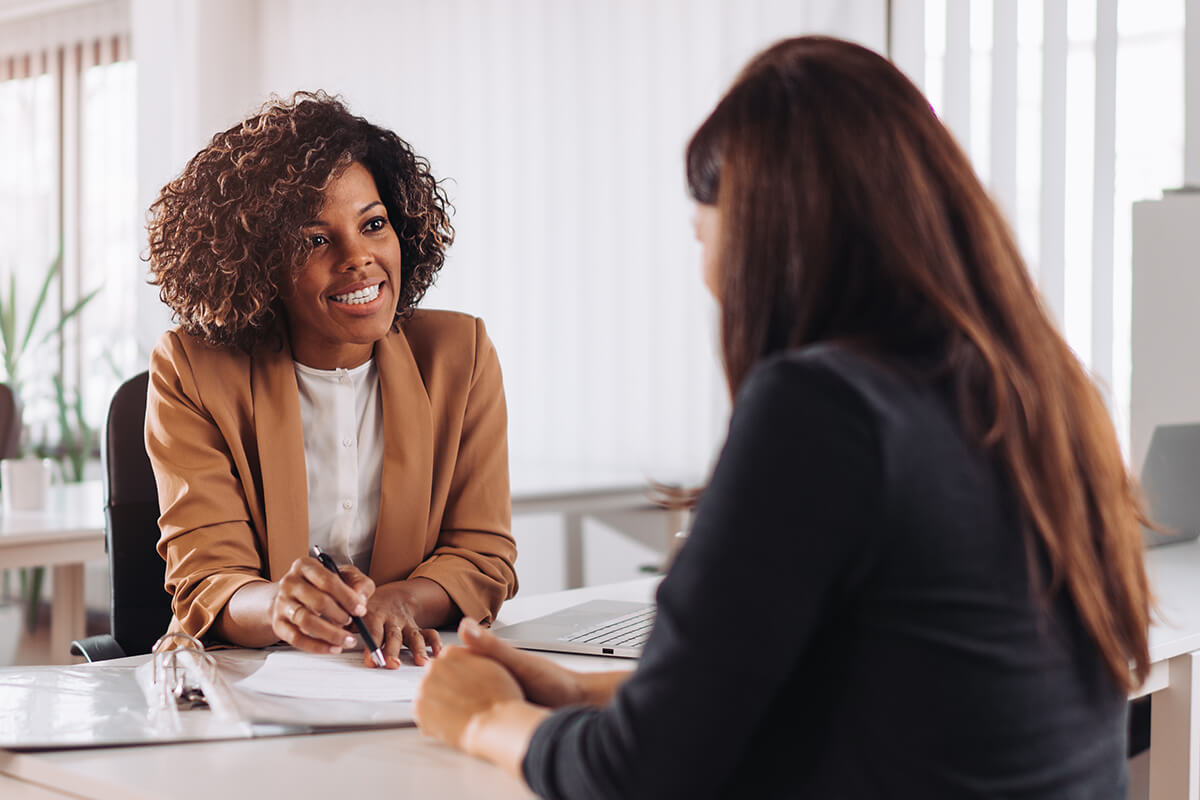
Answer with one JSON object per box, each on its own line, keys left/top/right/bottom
{"left": 0, "top": 25, "right": 137, "bottom": 472}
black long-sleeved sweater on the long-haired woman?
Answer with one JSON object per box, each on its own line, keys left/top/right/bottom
{"left": 524, "top": 344, "right": 1126, "bottom": 800}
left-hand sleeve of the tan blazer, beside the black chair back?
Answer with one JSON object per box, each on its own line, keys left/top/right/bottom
{"left": 145, "top": 333, "right": 265, "bottom": 638}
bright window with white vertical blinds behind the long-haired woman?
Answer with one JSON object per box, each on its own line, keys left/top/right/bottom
{"left": 893, "top": 0, "right": 1183, "bottom": 445}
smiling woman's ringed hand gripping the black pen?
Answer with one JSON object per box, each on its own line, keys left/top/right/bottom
{"left": 270, "top": 555, "right": 374, "bottom": 652}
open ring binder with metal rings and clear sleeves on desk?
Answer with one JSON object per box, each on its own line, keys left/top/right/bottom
{"left": 0, "top": 633, "right": 413, "bottom": 751}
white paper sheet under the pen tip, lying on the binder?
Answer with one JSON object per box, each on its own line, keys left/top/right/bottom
{"left": 234, "top": 650, "right": 425, "bottom": 702}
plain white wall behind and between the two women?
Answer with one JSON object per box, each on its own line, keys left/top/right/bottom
{"left": 133, "top": 0, "right": 886, "bottom": 477}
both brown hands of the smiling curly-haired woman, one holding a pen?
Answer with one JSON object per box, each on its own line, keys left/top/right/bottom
{"left": 270, "top": 555, "right": 442, "bottom": 669}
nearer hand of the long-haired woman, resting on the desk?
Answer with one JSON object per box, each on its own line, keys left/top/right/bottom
{"left": 413, "top": 648, "right": 524, "bottom": 757}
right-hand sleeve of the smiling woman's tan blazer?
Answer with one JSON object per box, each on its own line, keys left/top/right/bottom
{"left": 409, "top": 319, "right": 517, "bottom": 624}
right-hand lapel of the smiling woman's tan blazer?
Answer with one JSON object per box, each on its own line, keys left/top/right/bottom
{"left": 371, "top": 332, "right": 433, "bottom": 583}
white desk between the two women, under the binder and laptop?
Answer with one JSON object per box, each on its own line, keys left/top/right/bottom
{"left": 0, "top": 563, "right": 1200, "bottom": 800}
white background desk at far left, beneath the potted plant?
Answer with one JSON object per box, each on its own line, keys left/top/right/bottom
{"left": 0, "top": 481, "right": 104, "bottom": 663}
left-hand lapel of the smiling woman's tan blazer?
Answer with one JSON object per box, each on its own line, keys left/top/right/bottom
{"left": 251, "top": 341, "right": 308, "bottom": 581}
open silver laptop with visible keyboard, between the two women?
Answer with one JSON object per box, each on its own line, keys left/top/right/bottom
{"left": 492, "top": 600, "right": 654, "bottom": 658}
